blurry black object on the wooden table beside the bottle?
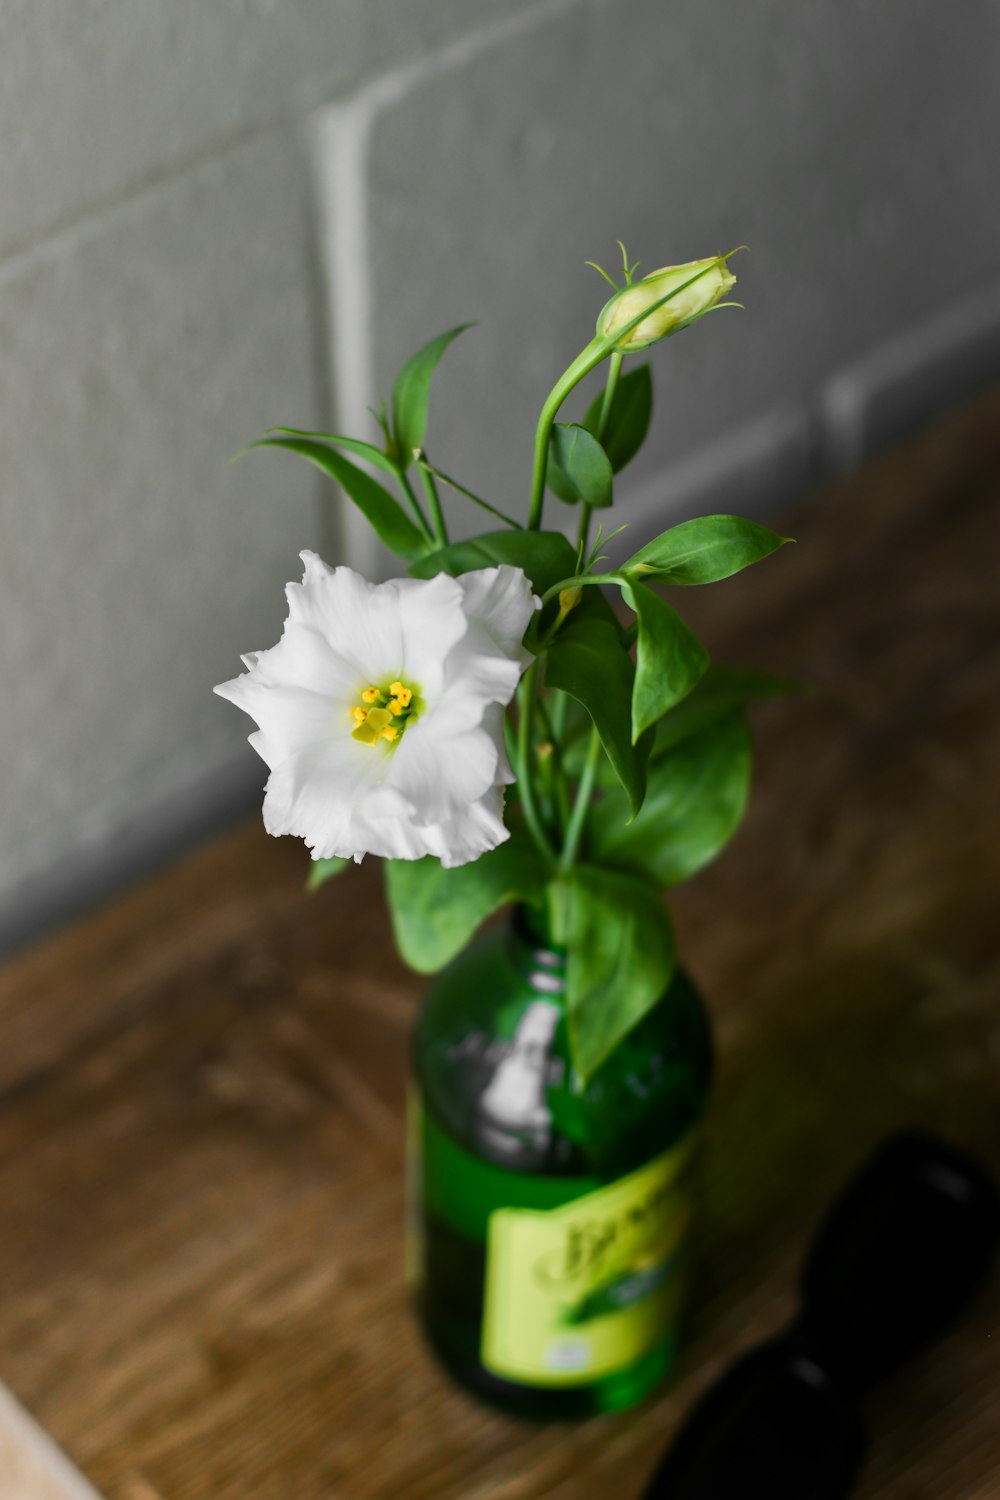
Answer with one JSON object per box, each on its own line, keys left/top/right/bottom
{"left": 643, "top": 1131, "right": 1000, "bottom": 1500}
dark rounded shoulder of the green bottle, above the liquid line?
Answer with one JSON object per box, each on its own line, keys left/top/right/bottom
{"left": 414, "top": 927, "right": 711, "bottom": 1176}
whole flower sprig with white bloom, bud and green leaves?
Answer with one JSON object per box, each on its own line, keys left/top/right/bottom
{"left": 216, "top": 249, "right": 790, "bottom": 1082}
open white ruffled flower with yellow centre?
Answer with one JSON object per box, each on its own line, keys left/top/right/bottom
{"left": 216, "top": 552, "right": 538, "bottom": 867}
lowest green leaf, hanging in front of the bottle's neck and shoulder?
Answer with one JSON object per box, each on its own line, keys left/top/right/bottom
{"left": 549, "top": 864, "right": 675, "bottom": 1082}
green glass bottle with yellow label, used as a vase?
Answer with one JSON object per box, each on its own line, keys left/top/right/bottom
{"left": 409, "top": 911, "right": 711, "bottom": 1421}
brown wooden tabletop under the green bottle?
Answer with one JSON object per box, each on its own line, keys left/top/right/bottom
{"left": 0, "top": 396, "right": 1000, "bottom": 1500}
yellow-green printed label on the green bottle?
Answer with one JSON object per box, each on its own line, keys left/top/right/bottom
{"left": 480, "top": 1136, "right": 691, "bottom": 1386}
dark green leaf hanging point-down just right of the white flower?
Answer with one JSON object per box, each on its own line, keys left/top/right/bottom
{"left": 546, "top": 615, "right": 654, "bottom": 813}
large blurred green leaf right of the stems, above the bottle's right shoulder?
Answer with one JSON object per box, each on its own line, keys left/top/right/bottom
{"left": 588, "top": 708, "right": 753, "bottom": 887}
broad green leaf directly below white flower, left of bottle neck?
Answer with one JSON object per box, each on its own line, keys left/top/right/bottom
{"left": 385, "top": 830, "right": 547, "bottom": 974}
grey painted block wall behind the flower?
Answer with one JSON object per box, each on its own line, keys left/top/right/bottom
{"left": 0, "top": 0, "right": 1000, "bottom": 939}
